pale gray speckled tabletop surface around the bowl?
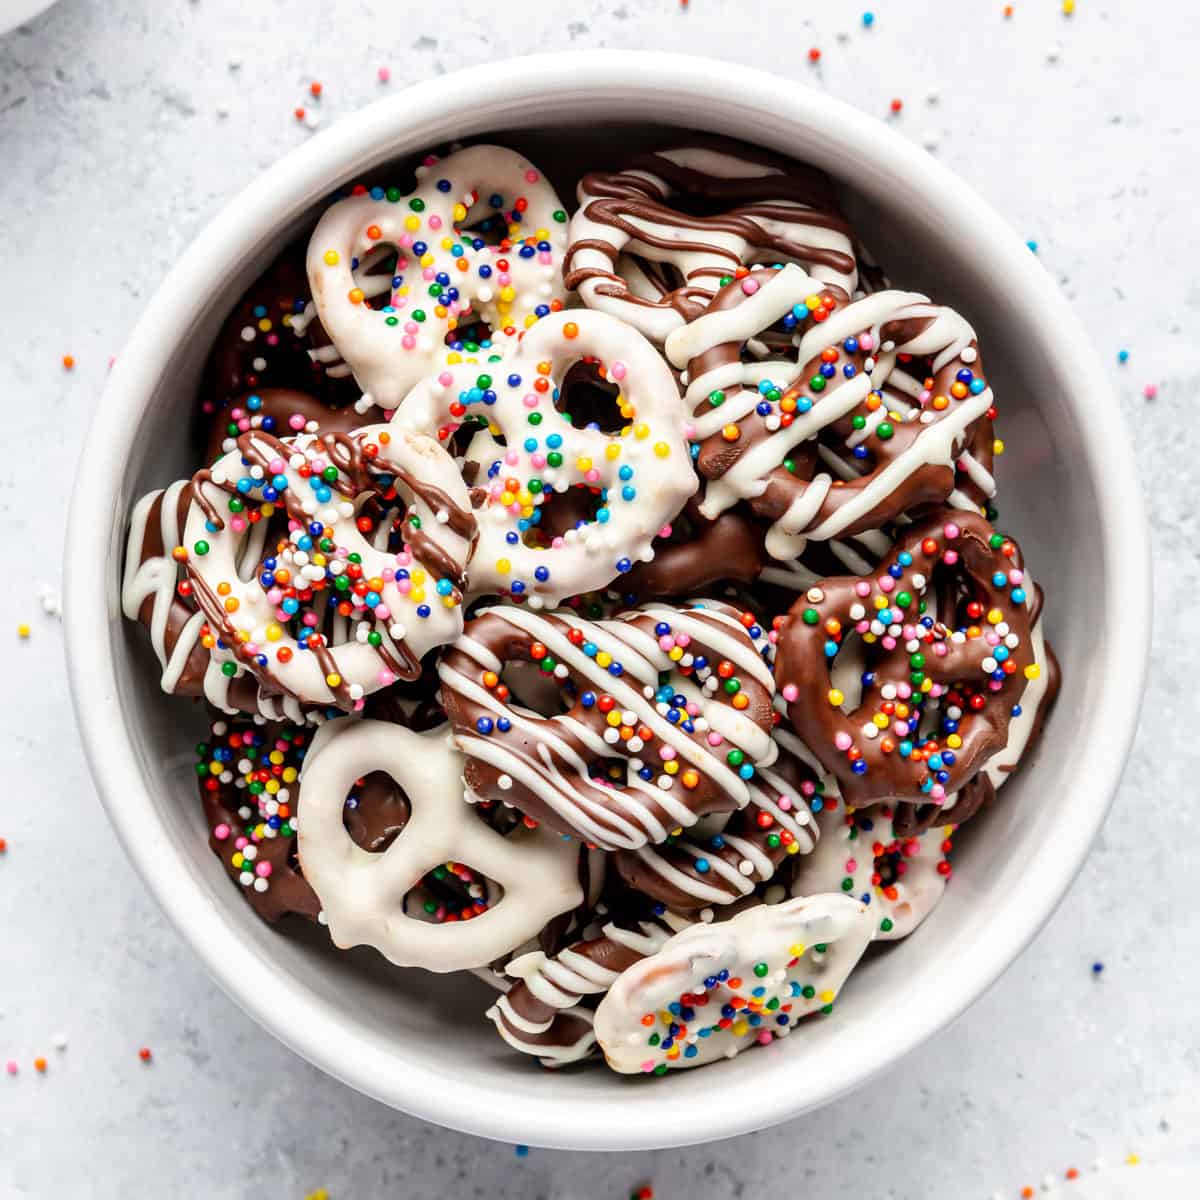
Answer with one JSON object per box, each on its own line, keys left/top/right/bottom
{"left": 0, "top": 0, "right": 1200, "bottom": 1200}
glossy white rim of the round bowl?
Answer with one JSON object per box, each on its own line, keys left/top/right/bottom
{"left": 64, "top": 50, "right": 1151, "bottom": 1150}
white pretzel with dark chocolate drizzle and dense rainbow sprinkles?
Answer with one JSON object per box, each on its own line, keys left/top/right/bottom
{"left": 182, "top": 425, "right": 475, "bottom": 708}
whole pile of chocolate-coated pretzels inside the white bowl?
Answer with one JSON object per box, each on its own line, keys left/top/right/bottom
{"left": 122, "top": 139, "right": 1058, "bottom": 1074}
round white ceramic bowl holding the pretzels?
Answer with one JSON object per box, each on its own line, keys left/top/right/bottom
{"left": 66, "top": 52, "right": 1150, "bottom": 1150}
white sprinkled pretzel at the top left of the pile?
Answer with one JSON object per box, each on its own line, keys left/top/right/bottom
{"left": 308, "top": 145, "right": 566, "bottom": 409}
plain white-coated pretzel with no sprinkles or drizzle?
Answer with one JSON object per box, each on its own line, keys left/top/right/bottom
{"left": 296, "top": 720, "right": 583, "bottom": 972}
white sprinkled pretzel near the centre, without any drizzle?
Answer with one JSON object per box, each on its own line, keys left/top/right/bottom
{"left": 392, "top": 311, "right": 700, "bottom": 607}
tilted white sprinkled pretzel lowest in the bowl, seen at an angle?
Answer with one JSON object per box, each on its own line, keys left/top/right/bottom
{"left": 595, "top": 895, "right": 872, "bottom": 1074}
